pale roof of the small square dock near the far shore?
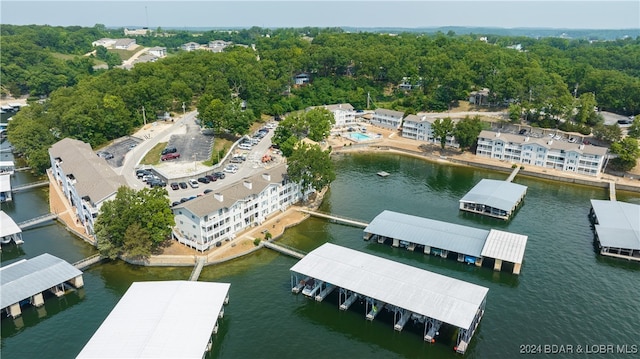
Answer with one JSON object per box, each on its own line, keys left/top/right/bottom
{"left": 460, "top": 179, "right": 527, "bottom": 212}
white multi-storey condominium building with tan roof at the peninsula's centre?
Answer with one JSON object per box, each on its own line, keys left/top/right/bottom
{"left": 173, "top": 164, "right": 304, "bottom": 251}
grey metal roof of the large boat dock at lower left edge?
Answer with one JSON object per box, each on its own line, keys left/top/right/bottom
{"left": 0, "top": 253, "right": 82, "bottom": 308}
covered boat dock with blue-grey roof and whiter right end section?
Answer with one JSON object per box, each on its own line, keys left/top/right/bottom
{"left": 364, "top": 211, "right": 527, "bottom": 274}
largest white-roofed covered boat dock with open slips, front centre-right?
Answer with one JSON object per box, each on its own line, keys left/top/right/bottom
{"left": 291, "top": 243, "right": 489, "bottom": 352}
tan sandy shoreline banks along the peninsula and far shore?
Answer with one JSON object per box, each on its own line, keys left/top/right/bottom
{"left": 49, "top": 128, "right": 640, "bottom": 267}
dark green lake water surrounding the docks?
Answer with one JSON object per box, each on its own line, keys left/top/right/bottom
{"left": 2, "top": 150, "right": 640, "bottom": 358}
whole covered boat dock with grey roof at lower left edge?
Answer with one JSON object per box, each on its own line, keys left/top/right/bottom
{"left": 0, "top": 253, "right": 84, "bottom": 318}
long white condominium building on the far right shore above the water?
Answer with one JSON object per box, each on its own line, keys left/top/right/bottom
{"left": 476, "top": 131, "right": 607, "bottom": 176}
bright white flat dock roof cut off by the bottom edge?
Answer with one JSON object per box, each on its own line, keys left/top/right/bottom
{"left": 77, "top": 281, "right": 230, "bottom": 359}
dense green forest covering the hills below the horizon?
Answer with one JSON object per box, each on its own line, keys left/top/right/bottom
{"left": 5, "top": 25, "right": 640, "bottom": 173}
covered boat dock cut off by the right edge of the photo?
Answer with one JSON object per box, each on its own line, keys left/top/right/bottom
{"left": 590, "top": 199, "right": 640, "bottom": 261}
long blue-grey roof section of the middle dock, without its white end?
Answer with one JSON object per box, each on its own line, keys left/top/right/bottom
{"left": 364, "top": 211, "right": 489, "bottom": 257}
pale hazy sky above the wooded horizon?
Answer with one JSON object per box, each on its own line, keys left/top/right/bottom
{"left": 0, "top": 0, "right": 640, "bottom": 29}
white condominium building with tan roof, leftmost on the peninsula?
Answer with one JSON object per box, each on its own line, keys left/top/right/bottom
{"left": 49, "top": 138, "right": 126, "bottom": 236}
